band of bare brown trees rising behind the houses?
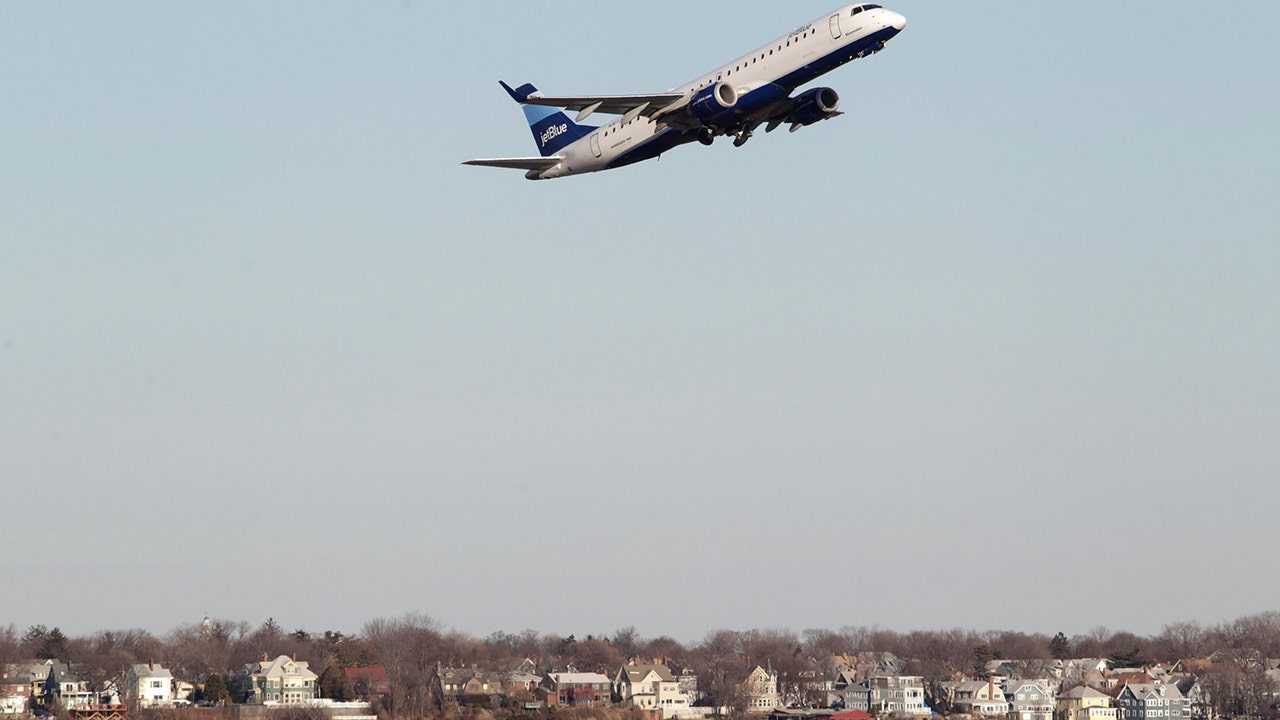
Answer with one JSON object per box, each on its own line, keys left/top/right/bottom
{"left": 0, "top": 611, "right": 1280, "bottom": 714}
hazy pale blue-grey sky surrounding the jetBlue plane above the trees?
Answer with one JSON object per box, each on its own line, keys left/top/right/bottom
{"left": 0, "top": 0, "right": 1280, "bottom": 641}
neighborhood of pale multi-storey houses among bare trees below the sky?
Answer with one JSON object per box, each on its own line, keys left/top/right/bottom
{"left": 0, "top": 616, "right": 1280, "bottom": 720}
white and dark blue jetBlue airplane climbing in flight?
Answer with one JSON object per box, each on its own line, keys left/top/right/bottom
{"left": 463, "top": 3, "right": 906, "bottom": 179}
